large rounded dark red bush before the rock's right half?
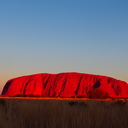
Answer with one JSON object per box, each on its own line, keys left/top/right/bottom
{"left": 87, "top": 88, "right": 109, "bottom": 99}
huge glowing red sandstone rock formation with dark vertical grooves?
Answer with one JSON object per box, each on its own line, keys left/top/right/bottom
{"left": 2, "top": 73, "right": 128, "bottom": 98}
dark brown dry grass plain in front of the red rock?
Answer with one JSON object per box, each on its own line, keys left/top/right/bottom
{"left": 0, "top": 98, "right": 128, "bottom": 128}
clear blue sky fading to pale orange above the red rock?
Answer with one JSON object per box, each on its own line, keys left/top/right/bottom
{"left": 0, "top": 0, "right": 128, "bottom": 92}
